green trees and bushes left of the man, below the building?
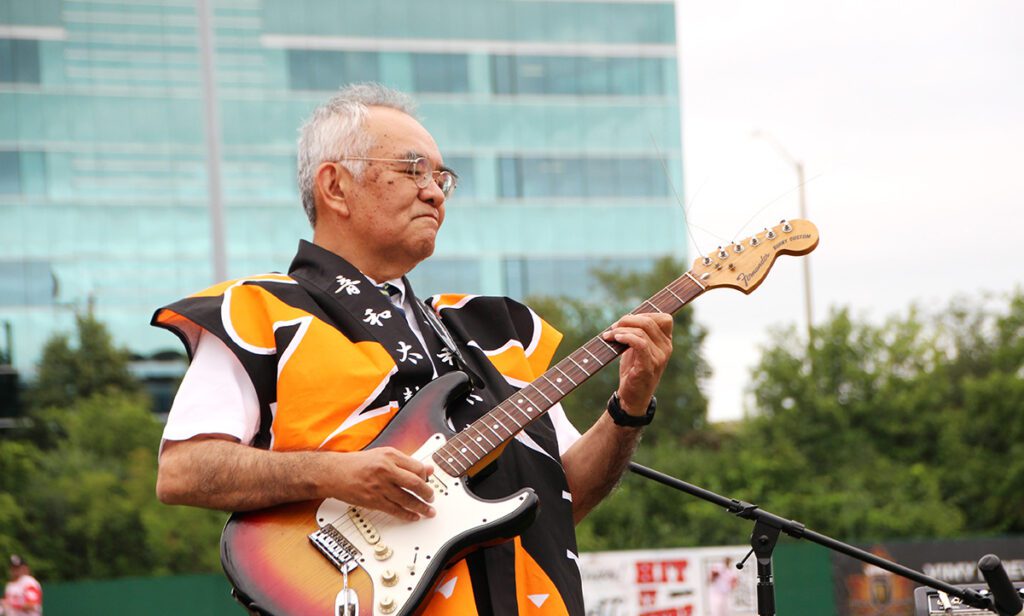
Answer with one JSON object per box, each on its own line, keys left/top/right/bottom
{"left": 0, "top": 317, "right": 224, "bottom": 580}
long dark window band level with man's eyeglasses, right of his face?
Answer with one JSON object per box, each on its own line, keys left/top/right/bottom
{"left": 498, "top": 158, "right": 669, "bottom": 199}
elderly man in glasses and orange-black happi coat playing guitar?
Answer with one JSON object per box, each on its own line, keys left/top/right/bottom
{"left": 154, "top": 84, "right": 672, "bottom": 616}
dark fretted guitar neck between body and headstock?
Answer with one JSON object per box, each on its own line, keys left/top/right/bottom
{"left": 433, "top": 272, "right": 705, "bottom": 477}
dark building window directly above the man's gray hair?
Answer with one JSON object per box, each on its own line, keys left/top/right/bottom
{"left": 288, "top": 49, "right": 381, "bottom": 90}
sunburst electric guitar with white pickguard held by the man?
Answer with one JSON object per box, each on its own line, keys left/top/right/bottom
{"left": 221, "top": 220, "right": 818, "bottom": 616}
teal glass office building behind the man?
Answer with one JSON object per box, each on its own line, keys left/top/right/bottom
{"left": 0, "top": 0, "right": 685, "bottom": 375}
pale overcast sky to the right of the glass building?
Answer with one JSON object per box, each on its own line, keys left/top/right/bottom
{"left": 677, "top": 0, "right": 1024, "bottom": 421}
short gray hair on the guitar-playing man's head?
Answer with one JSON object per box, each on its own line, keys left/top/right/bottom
{"left": 298, "top": 83, "right": 416, "bottom": 227}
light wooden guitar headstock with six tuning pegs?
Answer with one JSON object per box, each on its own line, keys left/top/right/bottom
{"left": 690, "top": 219, "right": 818, "bottom": 294}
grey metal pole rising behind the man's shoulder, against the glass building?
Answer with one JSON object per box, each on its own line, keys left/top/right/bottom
{"left": 196, "top": 0, "right": 227, "bottom": 282}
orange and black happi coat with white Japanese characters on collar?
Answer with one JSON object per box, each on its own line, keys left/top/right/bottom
{"left": 153, "top": 241, "right": 584, "bottom": 616}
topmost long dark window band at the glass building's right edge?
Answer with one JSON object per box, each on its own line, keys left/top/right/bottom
{"left": 492, "top": 55, "right": 674, "bottom": 96}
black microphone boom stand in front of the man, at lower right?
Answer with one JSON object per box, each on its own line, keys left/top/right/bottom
{"left": 630, "top": 461, "right": 1011, "bottom": 616}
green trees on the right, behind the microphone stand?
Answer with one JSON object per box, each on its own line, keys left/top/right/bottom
{"left": 562, "top": 270, "right": 1024, "bottom": 549}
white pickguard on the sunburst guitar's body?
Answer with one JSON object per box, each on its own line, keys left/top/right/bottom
{"left": 316, "top": 434, "right": 528, "bottom": 616}
